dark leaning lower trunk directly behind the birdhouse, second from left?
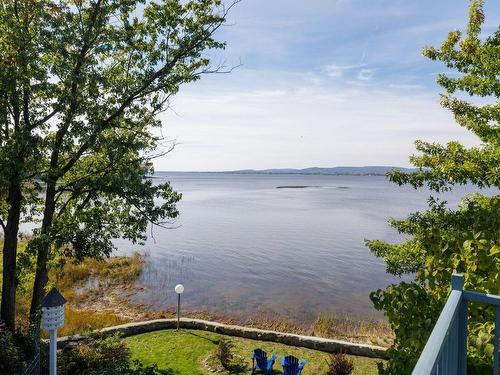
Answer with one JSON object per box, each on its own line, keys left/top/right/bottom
{"left": 30, "top": 181, "right": 56, "bottom": 334}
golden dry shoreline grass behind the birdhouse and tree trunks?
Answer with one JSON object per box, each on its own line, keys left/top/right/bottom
{"left": 4, "top": 242, "right": 144, "bottom": 335}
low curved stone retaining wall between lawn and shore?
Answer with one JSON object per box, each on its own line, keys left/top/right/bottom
{"left": 57, "top": 318, "right": 387, "bottom": 359}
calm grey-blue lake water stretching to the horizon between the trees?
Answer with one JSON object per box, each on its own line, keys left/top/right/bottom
{"left": 117, "top": 173, "right": 486, "bottom": 320}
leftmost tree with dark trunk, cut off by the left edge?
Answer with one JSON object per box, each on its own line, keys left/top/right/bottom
{"left": 0, "top": 1, "right": 49, "bottom": 330}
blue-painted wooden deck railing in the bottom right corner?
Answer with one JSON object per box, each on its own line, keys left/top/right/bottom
{"left": 412, "top": 274, "right": 500, "bottom": 375}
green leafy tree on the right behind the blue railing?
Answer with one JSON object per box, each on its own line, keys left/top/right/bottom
{"left": 366, "top": 0, "right": 500, "bottom": 375}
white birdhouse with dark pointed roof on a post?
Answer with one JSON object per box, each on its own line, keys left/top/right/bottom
{"left": 42, "top": 288, "right": 66, "bottom": 375}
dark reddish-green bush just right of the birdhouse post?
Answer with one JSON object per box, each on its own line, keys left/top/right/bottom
{"left": 58, "top": 336, "right": 159, "bottom": 375}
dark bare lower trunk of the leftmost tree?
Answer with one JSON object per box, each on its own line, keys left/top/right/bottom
{"left": 0, "top": 181, "right": 22, "bottom": 331}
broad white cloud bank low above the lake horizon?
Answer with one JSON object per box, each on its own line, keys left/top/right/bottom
{"left": 156, "top": 77, "right": 476, "bottom": 170}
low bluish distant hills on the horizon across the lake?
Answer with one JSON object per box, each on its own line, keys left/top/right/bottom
{"left": 222, "top": 165, "right": 414, "bottom": 176}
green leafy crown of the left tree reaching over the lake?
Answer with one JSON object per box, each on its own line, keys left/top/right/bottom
{"left": 18, "top": 0, "right": 233, "bottom": 260}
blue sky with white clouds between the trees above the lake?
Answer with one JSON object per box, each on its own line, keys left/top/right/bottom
{"left": 155, "top": 0, "right": 500, "bottom": 171}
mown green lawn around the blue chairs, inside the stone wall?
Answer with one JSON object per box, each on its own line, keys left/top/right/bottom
{"left": 125, "top": 330, "right": 379, "bottom": 375}
